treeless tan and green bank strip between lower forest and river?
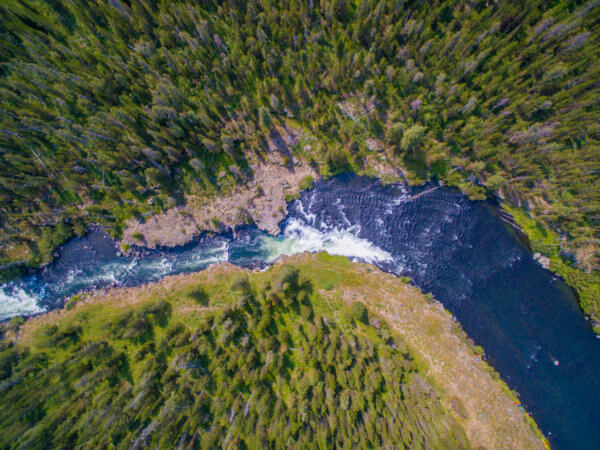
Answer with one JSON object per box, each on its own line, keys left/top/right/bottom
{"left": 9, "top": 253, "right": 544, "bottom": 449}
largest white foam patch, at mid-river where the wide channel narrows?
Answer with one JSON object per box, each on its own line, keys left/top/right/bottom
{"left": 262, "top": 218, "right": 393, "bottom": 263}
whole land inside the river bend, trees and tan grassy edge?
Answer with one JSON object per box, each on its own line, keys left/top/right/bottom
{"left": 0, "top": 254, "right": 544, "bottom": 448}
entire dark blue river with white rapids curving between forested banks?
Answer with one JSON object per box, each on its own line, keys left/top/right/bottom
{"left": 0, "top": 175, "right": 600, "bottom": 449}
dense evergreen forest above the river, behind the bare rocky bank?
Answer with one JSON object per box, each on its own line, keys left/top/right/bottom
{"left": 0, "top": 0, "right": 600, "bottom": 271}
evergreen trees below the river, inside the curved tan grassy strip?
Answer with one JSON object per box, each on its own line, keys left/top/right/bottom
{"left": 0, "top": 265, "right": 474, "bottom": 448}
